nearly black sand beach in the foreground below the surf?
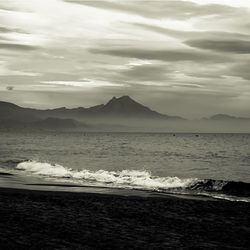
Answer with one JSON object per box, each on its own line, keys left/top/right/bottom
{"left": 0, "top": 188, "right": 250, "bottom": 250}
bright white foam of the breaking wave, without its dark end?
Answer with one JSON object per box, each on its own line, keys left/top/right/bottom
{"left": 16, "top": 161, "right": 196, "bottom": 190}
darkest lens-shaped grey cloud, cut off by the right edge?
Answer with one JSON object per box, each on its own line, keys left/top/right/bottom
{"left": 185, "top": 39, "right": 250, "bottom": 54}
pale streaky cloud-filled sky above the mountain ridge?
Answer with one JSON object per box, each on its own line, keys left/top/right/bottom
{"left": 0, "top": 0, "right": 250, "bottom": 118}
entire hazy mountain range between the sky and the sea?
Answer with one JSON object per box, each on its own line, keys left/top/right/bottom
{"left": 0, "top": 96, "right": 250, "bottom": 133}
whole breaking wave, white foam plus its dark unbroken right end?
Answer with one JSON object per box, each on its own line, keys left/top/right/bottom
{"left": 16, "top": 161, "right": 250, "bottom": 198}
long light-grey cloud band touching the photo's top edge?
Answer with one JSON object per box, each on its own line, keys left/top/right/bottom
{"left": 66, "top": 0, "right": 241, "bottom": 20}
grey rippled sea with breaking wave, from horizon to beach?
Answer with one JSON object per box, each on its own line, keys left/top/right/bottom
{"left": 0, "top": 132, "right": 250, "bottom": 202}
